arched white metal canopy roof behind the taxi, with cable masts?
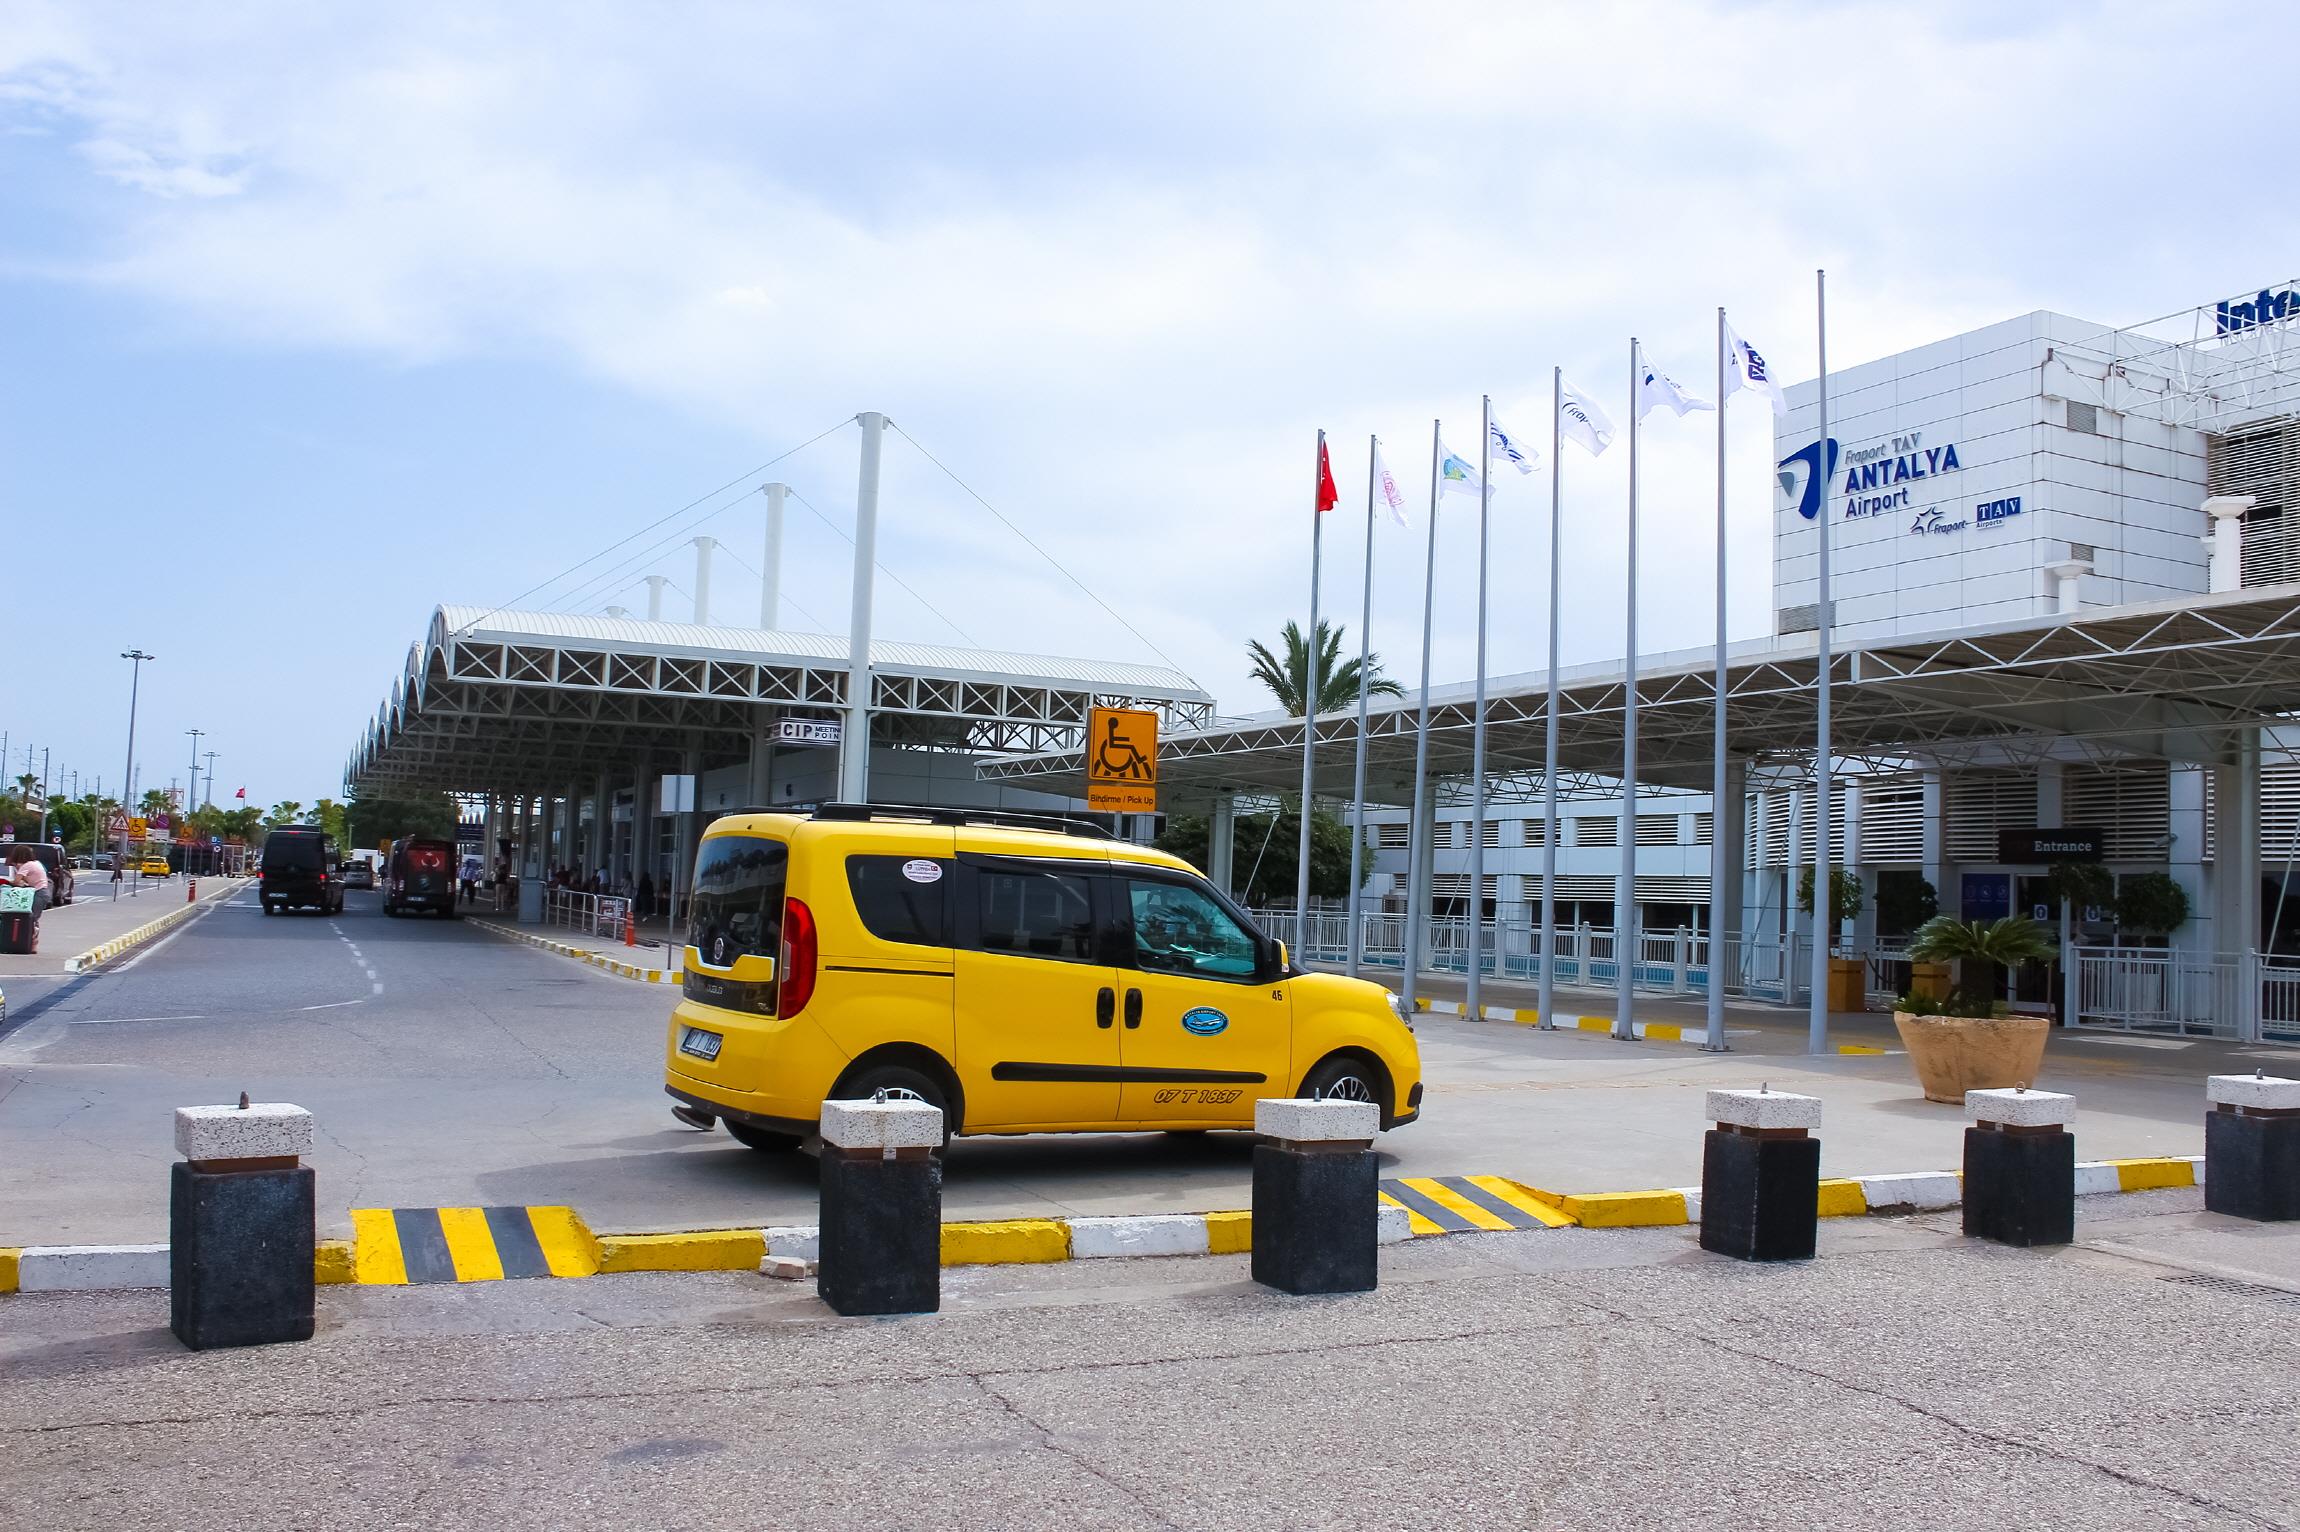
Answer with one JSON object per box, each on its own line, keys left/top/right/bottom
{"left": 345, "top": 607, "right": 1214, "bottom": 794}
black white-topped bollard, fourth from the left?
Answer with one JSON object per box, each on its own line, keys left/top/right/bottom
{"left": 1702, "top": 1090, "right": 1822, "bottom": 1261}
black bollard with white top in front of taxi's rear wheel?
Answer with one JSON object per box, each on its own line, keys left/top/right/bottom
{"left": 814, "top": 1097, "right": 943, "bottom": 1313}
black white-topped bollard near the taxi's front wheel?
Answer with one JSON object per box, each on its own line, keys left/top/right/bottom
{"left": 1254, "top": 1100, "right": 1382, "bottom": 1295}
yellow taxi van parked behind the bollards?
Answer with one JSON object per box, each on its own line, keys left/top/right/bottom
{"left": 665, "top": 803, "right": 1421, "bottom": 1150}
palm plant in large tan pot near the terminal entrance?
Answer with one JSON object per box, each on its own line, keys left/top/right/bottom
{"left": 1893, "top": 916, "right": 2054, "bottom": 1106}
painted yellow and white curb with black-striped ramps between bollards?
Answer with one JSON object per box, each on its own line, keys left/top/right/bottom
{"left": 0, "top": 1155, "right": 2203, "bottom": 1293}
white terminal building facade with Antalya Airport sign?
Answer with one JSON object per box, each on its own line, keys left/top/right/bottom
{"left": 1369, "top": 285, "right": 2300, "bottom": 955}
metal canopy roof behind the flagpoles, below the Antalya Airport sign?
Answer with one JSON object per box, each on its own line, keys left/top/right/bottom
{"left": 978, "top": 584, "right": 2300, "bottom": 803}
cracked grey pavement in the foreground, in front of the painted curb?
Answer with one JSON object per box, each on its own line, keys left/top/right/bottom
{"left": 0, "top": 1196, "right": 2300, "bottom": 1532}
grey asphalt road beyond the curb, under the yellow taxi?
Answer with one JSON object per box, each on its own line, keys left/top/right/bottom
{"left": 0, "top": 890, "right": 2293, "bottom": 1244}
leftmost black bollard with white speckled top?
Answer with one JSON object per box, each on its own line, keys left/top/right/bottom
{"left": 168, "top": 1097, "right": 317, "bottom": 1350}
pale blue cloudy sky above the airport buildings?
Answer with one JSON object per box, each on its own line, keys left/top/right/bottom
{"left": 0, "top": 0, "right": 2300, "bottom": 803}
